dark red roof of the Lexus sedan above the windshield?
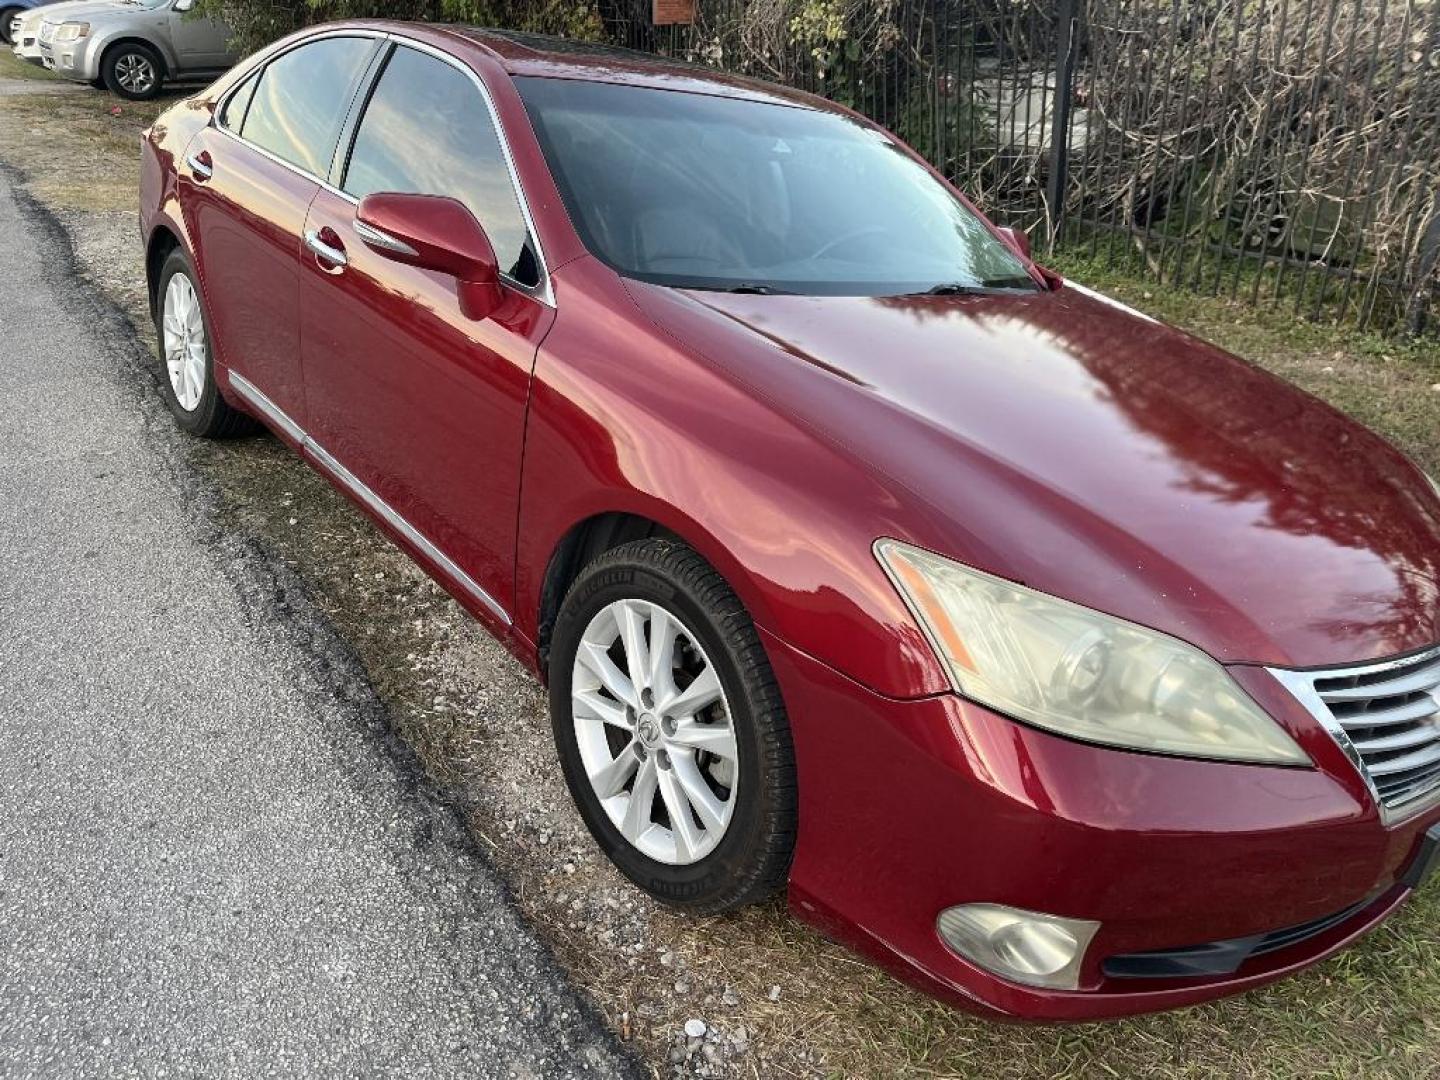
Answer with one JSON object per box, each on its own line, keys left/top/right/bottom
{"left": 432, "top": 23, "right": 834, "bottom": 109}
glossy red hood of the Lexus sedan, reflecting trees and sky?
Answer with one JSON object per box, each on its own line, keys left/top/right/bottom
{"left": 631, "top": 282, "right": 1440, "bottom": 667}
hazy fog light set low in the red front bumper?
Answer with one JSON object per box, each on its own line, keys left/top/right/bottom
{"left": 936, "top": 904, "right": 1100, "bottom": 989}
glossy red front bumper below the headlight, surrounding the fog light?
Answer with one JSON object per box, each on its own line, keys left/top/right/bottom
{"left": 765, "top": 635, "right": 1440, "bottom": 1021}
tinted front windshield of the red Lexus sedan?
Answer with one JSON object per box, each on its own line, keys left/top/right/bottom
{"left": 516, "top": 78, "right": 1037, "bottom": 295}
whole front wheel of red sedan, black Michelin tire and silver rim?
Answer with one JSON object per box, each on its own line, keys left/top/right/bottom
{"left": 550, "top": 537, "right": 798, "bottom": 914}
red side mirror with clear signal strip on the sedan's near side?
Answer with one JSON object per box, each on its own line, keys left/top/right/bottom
{"left": 354, "top": 192, "right": 504, "bottom": 320}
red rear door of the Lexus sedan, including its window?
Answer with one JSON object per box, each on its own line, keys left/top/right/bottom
{"left": 179, "top": 36, "right": 379, "bottom": 425}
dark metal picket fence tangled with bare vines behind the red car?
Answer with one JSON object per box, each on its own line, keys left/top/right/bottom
{"left": 600, "top": 0, "right": 1440, "bottom": 331}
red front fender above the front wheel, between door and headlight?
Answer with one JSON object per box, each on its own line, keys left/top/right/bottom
{"left": 514, "top": 258, "right": 948, "bottom": 697}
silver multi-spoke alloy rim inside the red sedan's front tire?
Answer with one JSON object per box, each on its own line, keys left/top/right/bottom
{"left": 570, "top": 600, "right": 739, "bottom": 865}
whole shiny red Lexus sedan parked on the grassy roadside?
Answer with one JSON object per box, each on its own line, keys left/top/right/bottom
{"left": 140, "top": 23, "right": 1440, "bottom": 1020}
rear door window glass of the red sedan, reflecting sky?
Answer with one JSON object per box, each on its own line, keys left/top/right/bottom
{"left": 240, "top": 37, "right": 374, "bottom": 177}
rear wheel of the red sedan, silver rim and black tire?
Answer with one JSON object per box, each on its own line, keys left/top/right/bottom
{"left": 154, "top": 248, "right": 258, "bottom": 439}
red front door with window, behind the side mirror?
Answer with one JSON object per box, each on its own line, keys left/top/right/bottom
{"left": 301, "top": 45, "right": 554, "bottom": 622}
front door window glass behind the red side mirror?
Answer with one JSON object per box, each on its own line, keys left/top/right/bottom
{"left": 343, "top": 48, "right": 540, "bottom": 285}
